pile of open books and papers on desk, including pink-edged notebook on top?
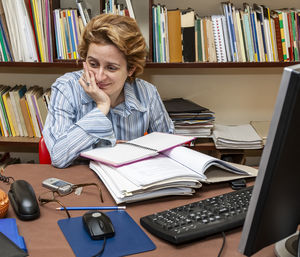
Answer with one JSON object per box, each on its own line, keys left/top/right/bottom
{"left": 82, "top": 132, "right": 257, "bottom": 204}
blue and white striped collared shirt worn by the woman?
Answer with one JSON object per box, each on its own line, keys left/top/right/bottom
{"left": 43, "top": 71, "right": 174, "bottom": 168}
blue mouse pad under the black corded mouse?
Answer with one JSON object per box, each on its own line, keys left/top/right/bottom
{"left": 57, "top": 211, "right": 156, "bottom": 257}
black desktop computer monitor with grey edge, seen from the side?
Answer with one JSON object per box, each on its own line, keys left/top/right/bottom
{"left": 239, "top": 65, "right": 300, "bottom": 256}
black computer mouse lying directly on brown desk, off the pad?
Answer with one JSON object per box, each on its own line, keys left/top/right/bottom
{"left": 8, "top": 180, "right": 40, "bottom": 220}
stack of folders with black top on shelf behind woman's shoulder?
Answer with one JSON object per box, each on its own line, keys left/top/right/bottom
{"left": 163, "top": 98, "right": 215, "bottom": 137}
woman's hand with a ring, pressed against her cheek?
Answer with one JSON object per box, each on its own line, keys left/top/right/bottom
{"left": 79, "top": 62, "right": 110, "bottom": 115}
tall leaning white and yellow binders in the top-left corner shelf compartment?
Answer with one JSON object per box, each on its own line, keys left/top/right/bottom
{"left": 0, "top": 0, "right": 53, "bottom": 62}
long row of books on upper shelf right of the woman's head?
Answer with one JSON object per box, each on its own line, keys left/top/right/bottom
{"left": 152, "top": 2, "right": 300, "bottom": 62}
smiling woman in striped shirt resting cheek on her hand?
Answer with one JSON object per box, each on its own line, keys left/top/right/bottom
{"left": 43, "top": 14, "right": 174, "bottom": 168}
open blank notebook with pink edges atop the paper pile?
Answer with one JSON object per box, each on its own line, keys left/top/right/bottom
{"left": 80, "top": 132, "right": 194, "bottom": 167}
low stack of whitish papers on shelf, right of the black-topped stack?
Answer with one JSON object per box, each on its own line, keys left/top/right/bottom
{"left": 213, "top": 124, "right": 263, "bottom": 149}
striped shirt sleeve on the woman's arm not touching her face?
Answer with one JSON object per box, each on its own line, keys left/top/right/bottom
{"left": 148, "top": 89, "right": 174, "bottom": 134}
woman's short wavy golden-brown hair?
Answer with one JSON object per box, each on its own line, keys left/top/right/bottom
{"left": 78, "top": 14, "right": 147, "bottom": 81}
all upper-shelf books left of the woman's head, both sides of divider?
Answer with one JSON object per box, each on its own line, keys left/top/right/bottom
{"left": 0, "top": 0, "right": 90, "bottom": 62}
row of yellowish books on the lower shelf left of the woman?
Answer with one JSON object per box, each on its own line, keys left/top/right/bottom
{"left": 0, "top": 85, "right": 51, "bottom": 137}
